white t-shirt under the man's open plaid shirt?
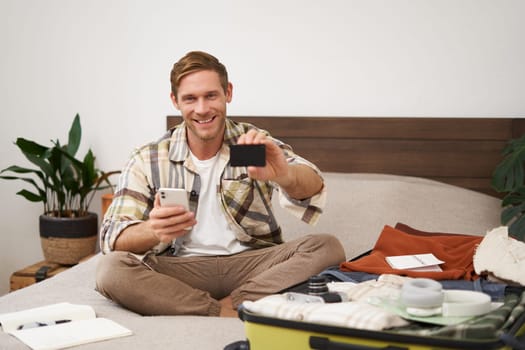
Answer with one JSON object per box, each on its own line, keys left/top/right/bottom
{"left": 177, "top": 152, "right": 250, "bottom": 256}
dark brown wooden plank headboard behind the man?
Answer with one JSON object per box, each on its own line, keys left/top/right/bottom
{"left": 167, "top": 116, "right": 525, "bottom": 196}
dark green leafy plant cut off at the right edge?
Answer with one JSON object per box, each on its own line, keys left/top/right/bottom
{"left": 492, "top": 135, "right": 525, "bottom": 242}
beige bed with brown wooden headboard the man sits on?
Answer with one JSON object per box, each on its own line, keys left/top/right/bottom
{"left": 0, "top": 116, "right": 525, "bottom": 350}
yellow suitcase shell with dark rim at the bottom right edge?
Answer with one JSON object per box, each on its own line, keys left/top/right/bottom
{"left": 224, "top": 296, "right": 525, "bottom": 350}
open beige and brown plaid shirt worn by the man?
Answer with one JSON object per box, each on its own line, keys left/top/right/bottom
{"left": 100, "top": 119, "right": 326, "bottom": 254}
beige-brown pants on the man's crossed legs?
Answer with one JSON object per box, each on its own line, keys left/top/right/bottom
{"left": 96, "top": 234, "right": 345, "bottom": 316}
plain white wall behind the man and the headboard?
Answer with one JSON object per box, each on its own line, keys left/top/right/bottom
{"left": 0, "top": 0, "right": 525, "bottom": 294}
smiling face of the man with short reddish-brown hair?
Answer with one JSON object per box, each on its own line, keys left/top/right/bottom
{"left": 171, "top": 70, "right": 232, "bottom": 146}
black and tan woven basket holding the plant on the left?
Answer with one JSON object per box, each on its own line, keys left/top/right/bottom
{"left": 40, "top": 213, "right": 98, "bottom": 265}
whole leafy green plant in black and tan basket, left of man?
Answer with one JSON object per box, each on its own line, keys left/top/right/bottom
{"left": 0, "top": 114, "right": 118, "bottom": 265}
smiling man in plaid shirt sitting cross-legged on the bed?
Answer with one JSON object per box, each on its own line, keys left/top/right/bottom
{"left": 97, "top": 51, "right": 345, "bottom": 316}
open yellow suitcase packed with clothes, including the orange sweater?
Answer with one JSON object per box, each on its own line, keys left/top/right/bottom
{"left": 225, "top": 225, "right": 525, "bottom": 350}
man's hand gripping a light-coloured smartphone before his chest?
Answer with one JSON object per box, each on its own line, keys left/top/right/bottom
{"left": 149, "top": 188, "right": 197, "bottom": 243}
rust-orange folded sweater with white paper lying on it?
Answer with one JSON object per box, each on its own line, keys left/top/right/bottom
{"left": 340, "top": 225, "right": 483, "bottom": 280}
